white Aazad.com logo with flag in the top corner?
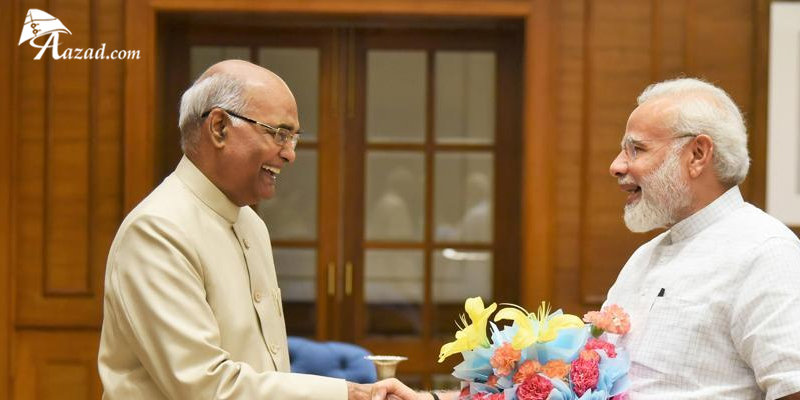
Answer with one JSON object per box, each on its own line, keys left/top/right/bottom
{"left": 17, "top": 8, "right": 139, "bottom": 60}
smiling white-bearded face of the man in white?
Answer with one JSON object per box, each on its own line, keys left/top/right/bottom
{"left": 610, "top": 101, "right": 692, "bottom": 232}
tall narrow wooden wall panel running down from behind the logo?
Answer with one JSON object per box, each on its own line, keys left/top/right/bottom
{"left": 47, "top": 0, "right": 92, "bottom": 296}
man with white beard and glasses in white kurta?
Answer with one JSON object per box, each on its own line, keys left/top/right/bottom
{"left": 606, "top": 78, "right": 800, "bottom": 400}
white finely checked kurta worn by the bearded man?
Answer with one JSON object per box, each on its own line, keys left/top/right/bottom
{"left": 606, "top": 187, "right": 800, "bottom": 400}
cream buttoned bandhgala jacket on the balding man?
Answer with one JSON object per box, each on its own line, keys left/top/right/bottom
{"left": 98, "top": 157, "right": 347, "bottom": 400}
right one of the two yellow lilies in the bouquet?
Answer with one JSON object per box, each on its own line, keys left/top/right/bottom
{"left": 494, "top": 302, "right": 584, "bottom": 350}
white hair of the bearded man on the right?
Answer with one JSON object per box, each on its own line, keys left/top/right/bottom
{"left": 637, "top": 78, "right": 750, "bottom": 186}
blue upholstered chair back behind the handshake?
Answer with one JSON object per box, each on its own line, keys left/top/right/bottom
{"left": 289, "top": 336, "right": 378, "bottom": 383}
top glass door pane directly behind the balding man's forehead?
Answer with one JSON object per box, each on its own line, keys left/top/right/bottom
{"left": 258, "top": 47, "right": 319, "bottom": 142}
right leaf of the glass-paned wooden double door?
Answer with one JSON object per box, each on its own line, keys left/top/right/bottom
{"left": 341, "top": 29, "right": 521, "bottom": 387}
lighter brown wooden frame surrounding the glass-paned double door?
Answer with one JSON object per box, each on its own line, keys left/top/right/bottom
{"left": 124, "top": 0, "right": 558, "bottom": 306}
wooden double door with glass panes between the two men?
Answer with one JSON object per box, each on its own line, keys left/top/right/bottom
{"left": 156, "top": 17, "right": 521, "bottom": 387}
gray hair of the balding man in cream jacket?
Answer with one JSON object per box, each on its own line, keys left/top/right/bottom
{"left": 178, "top": 73, "right": 247, "bottom": 153}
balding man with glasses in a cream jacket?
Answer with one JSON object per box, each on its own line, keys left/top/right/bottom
{"left": 98, "top": 60, "right": 412, "bottom": 400}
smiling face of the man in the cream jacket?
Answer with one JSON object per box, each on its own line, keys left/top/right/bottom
{"left": 217, "top": 76, "right": 299, "bottom": 206}
